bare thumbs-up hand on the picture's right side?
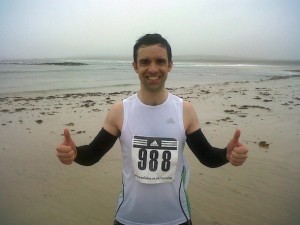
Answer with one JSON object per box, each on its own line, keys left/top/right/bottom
{"left": 226, "top": 129, "right": 248, "bottom": 166}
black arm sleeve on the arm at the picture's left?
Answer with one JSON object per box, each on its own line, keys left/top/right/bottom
{"left": 74, "top": 128, "right": 118, "bottom": 166}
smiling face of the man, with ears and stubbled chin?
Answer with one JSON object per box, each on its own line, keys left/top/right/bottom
{"left": 132, "top": 45, "right": 173, "bottom": 92}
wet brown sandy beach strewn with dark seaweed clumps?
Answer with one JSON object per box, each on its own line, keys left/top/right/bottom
{"left": 0, "top": 76, "right": 300, "bottom": 225}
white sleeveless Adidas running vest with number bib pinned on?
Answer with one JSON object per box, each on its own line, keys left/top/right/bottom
{"left": 116, "top": 93, "right": 190, "bottom": 225}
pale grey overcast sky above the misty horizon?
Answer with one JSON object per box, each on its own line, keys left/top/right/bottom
{"left": 0, "top": 0, "right": 300, "bottom": 59}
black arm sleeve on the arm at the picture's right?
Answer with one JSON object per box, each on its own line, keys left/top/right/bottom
{"left": 186, "top": 129, "right": 228, "bottom": 168}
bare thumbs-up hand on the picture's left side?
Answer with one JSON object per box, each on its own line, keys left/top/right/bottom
{"left": 56, "top": 129, "right": 77, "bottom": 165}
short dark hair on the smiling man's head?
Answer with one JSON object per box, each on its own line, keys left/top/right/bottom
{"left": 133, "top": 34, "right": 172, "bottom": 62}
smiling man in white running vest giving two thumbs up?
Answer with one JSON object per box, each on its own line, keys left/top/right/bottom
{"left": 57, "top": 34, "right": 248, "bottom": 225}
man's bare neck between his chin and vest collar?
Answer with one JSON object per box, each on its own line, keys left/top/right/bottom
{"left": 137, "top": 89, "right": 169, "bottom": 106}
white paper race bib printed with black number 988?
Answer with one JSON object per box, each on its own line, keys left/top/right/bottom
{"left": 132, "top": 136, "right": 178, "bottom": 184}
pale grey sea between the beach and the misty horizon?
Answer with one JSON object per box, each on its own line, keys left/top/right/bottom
{"left": 0, "top": 57, "right": 300, "bottom": 96}
